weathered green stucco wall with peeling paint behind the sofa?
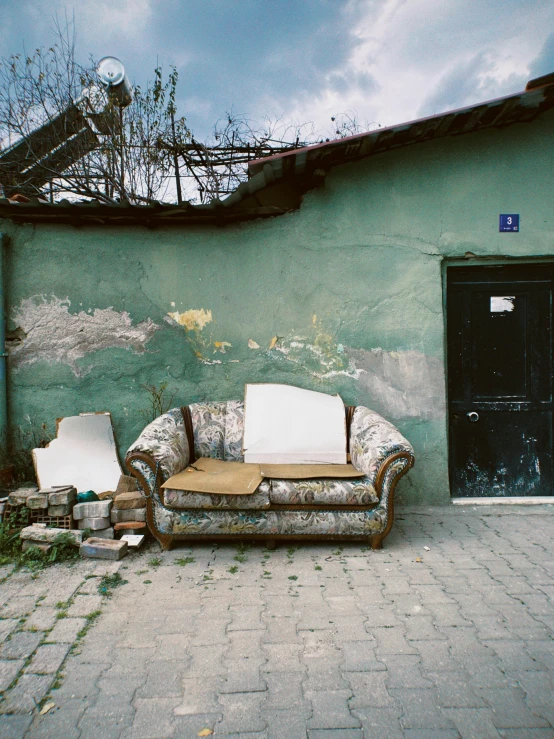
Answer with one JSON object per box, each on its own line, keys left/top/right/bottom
{"left": 0, "top": 113, "right": 554, "bottom": 503}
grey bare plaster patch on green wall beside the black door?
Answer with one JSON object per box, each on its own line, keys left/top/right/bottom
{"left": 345, "top": 347, "right": 446, "bottom": 418}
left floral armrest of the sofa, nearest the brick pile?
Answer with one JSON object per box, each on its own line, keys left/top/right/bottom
{"left": 125, "top": 408, "right": 190, "bottom": 482}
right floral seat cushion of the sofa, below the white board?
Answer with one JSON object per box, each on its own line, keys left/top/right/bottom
{"left": 269, "top": 477, "right": 379, "bottom": 506}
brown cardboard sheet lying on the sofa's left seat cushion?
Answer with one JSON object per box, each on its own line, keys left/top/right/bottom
{"left": 162, "top": 457, "right": 263, "bottom": 495}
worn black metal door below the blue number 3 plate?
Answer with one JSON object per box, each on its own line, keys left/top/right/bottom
{"left": 447, "top": 264, "right": 554, "bottom": 497}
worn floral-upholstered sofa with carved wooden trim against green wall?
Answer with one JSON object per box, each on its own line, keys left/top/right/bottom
{"left": 125, "top": 401, "right": 414, "bottom": 550}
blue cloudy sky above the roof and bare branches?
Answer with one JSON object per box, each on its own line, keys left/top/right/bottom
{"left": 0, "top": 0, "right": 554, "bottom": 137}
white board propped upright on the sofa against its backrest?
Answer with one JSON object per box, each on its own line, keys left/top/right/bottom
{"left": 243, "top": 383, "right": 346, "bottom": 464}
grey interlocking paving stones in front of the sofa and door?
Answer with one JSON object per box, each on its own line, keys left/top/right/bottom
{"left": 0, "top": 506, "right": 554, "bottom": 739}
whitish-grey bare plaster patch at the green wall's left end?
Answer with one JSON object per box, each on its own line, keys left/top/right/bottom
{"left": 10, "top": 295, "right": 160, "bottom": 376}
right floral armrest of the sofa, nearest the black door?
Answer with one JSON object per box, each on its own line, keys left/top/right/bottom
{"left": 350, "top": 405, "right": 414, "bottom": 484}
